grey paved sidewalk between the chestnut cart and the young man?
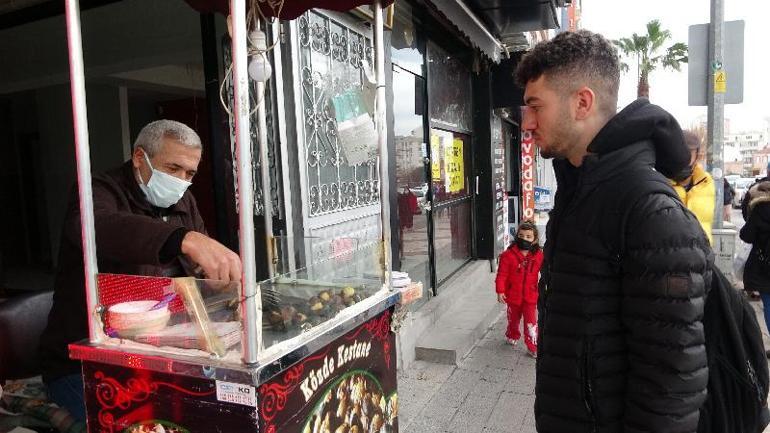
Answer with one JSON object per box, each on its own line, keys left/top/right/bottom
{"left": 398, "top": 286, "right": 770, "bottom": 433}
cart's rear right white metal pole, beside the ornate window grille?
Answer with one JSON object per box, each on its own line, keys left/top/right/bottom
{"left": 372, "top": 0, "right": 393, "bottom": 289}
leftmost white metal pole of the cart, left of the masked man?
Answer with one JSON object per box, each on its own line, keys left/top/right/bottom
{"left": 64, "top": 0, "right": 103, "bottom": 343}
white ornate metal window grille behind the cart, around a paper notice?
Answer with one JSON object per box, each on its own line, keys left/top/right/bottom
{"left": 298, "top": 11, "right": 380, "bottom": 216}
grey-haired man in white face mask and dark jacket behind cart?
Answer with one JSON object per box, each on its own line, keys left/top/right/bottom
{"left": 40, "top": 120, "right": 241, "bottom": 420}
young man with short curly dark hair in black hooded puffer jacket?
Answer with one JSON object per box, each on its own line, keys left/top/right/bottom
{"left": 516, "top": 31, "right": 713, "bottom": 433}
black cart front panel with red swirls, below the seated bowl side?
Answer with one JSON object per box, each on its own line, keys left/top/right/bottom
{"left": 83, "top": 358, "right": 258, "bottom": 433}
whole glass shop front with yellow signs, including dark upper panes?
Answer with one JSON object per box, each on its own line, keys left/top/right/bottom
{"left": 391, "top": 10, "right": 474, "bottom": 295}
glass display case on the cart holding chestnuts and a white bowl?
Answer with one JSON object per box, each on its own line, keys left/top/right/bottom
{"left": 88, "top": 238, "right": 390, "bottom": 363}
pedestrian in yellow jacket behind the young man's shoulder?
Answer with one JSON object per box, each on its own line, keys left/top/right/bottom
{"left": 671, "top": 131, "right": 716, "bottom": 243}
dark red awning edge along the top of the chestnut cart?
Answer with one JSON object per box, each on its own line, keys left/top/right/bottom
{"left": 185, "top": 0, "right": 393, "bottom": 20}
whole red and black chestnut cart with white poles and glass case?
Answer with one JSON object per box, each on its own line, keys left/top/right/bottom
{"left": 65, "top": 0, "right": 408, "bottom": 433}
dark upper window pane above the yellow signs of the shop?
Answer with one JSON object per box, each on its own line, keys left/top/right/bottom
{"left": 428, "top": 42, "right": 473, "bottom": 131}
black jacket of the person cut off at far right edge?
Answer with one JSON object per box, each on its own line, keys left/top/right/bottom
{"left": 741, "top": 178, "right": 770, "bottom": 293}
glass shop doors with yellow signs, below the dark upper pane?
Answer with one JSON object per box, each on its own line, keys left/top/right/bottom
{"left": 393, "top": 66, "right": 472, "bottom": 294}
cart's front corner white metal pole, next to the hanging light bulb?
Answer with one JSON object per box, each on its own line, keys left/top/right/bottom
{"left": 230, "top": 0, "right": 262, "bottom": 364}
